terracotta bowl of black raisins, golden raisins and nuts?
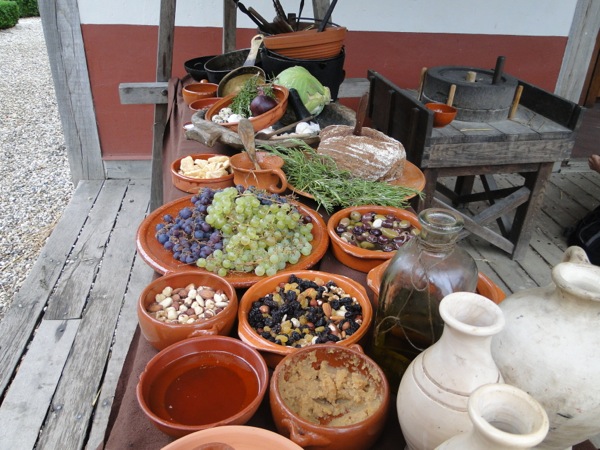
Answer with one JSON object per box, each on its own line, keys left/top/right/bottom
{"left": 238, "top": 270, "right": 373, "bottom": 368}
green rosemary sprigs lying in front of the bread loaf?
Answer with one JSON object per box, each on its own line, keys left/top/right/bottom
{"left": 261, "top": 140, "right": 422, "bottom": 213}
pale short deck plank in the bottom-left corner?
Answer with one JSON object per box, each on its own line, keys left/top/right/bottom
{"left": 0, "top": 320, "right": 79, "bottom": 450}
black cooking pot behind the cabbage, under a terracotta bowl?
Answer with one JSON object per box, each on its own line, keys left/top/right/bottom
{"left": 260, "top": 48, "right": 346, "bottom": 101}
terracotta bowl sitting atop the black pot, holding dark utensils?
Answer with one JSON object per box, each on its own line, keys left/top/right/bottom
{"left": 263, "top": 26, "right": 348, "bottom": 59}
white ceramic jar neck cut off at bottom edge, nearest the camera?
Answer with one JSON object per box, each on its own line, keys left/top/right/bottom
{"left": 436, "top": 384, "right": 549, "bottom": 450}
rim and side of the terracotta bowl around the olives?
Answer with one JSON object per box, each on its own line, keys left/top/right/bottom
{"left": 327, "top": 205, "right": 421, "bottom": 273}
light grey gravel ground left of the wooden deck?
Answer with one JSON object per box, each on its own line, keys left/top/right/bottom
{"left": 0, "top": 17, "right": 73, "bottom": 320}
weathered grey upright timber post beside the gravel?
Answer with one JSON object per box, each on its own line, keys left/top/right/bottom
{"left": 39, "top": 0, "right": 104, "bottom": 185}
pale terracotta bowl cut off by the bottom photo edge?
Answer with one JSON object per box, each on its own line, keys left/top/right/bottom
{"left": 162, "top": 425, "right": 302, "bottom": 450}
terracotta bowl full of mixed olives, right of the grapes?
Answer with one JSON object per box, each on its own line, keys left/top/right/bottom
{"left": 327, "top": 205, "right": 421, "bottom": 273}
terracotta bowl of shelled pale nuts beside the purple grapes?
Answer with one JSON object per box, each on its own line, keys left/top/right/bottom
{"left": 137, "top": 271, "right": 238, "bottom": 350}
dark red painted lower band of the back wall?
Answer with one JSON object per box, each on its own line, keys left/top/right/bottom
{"left": 82, "top": 25, "right": 567, "bottom": 160}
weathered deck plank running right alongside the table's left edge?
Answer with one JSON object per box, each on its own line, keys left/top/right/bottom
{"left": 86, "top": 255, "right": 156, "bottom": 449}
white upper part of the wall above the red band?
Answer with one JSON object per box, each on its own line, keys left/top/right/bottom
{"left": 79, "top": 0, "right": 577, "bottom": 36}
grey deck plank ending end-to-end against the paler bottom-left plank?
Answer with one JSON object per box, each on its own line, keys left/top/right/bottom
{"left": 45, "top": 180, "right": 128, "bottom": 320}
